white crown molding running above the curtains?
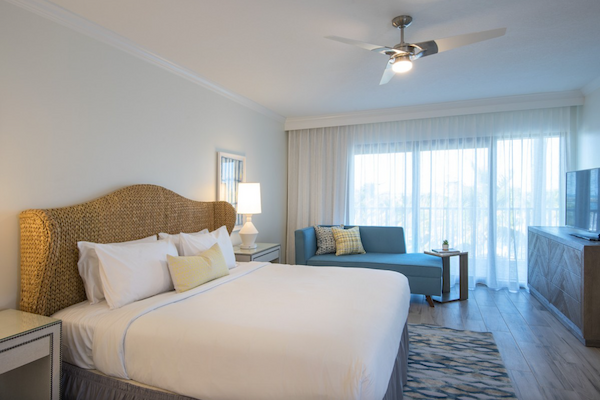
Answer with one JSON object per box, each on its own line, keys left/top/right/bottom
{"left": 285, "top": 90, "right": 584, "bottom": 131}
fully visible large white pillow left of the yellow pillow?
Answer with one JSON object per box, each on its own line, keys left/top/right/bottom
{"left": 96, "top": 240, "right": 178, "bottom": 309}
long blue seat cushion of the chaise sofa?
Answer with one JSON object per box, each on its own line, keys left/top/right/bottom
{"left": 307, "top": 253, "right": 442, "bottom": 278}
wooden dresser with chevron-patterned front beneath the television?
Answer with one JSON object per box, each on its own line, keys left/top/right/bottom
{"left": 528, "top": 226, "right": 600, "bottom": 347}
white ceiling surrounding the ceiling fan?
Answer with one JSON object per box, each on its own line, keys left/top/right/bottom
{"left": 45, "top": 0, "right": 600, "bottom": 117}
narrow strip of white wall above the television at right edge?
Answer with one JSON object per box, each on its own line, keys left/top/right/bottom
{"left": 575, "top": 89, "right": 600, "bottom": 169}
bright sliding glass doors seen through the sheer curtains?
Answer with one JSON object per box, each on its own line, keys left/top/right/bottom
{"left": 348, "top": 136, "right": 561, "bottom": 288}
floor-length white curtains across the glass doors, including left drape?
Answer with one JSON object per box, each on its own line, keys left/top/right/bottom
{"left": 288, "top": 107, "right": 571, "bottom": 290}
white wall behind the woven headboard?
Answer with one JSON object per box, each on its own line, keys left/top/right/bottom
{"left": 0, "top": 1, "right": 287, "bottom": 309}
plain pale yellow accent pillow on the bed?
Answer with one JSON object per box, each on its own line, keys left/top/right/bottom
{"left": 167, "top": 244, "right": 229, "bottom": 293}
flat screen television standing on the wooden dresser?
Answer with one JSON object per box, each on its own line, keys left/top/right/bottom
{"left": 566, "top": 168, "right": 600, "bottom": 240}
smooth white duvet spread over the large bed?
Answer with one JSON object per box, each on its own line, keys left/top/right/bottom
{"left": 54, "top": 263, "right": 410, "bottom": 400}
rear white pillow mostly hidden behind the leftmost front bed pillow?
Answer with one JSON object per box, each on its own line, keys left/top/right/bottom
{"left": 77, "top": 235, "right": 156, "bottom": 304}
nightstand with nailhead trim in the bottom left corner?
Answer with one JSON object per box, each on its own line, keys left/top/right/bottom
{"left": 0, "top": 310, "right": 62, "bottom": 400}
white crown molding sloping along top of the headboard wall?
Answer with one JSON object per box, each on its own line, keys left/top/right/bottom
{"left": 4, "top": 0, "right": 285, "bottom": 123}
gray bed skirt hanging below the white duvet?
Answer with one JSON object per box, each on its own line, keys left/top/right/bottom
{"left": 61, "top": 324, "right": 409, "bottom": 400}
